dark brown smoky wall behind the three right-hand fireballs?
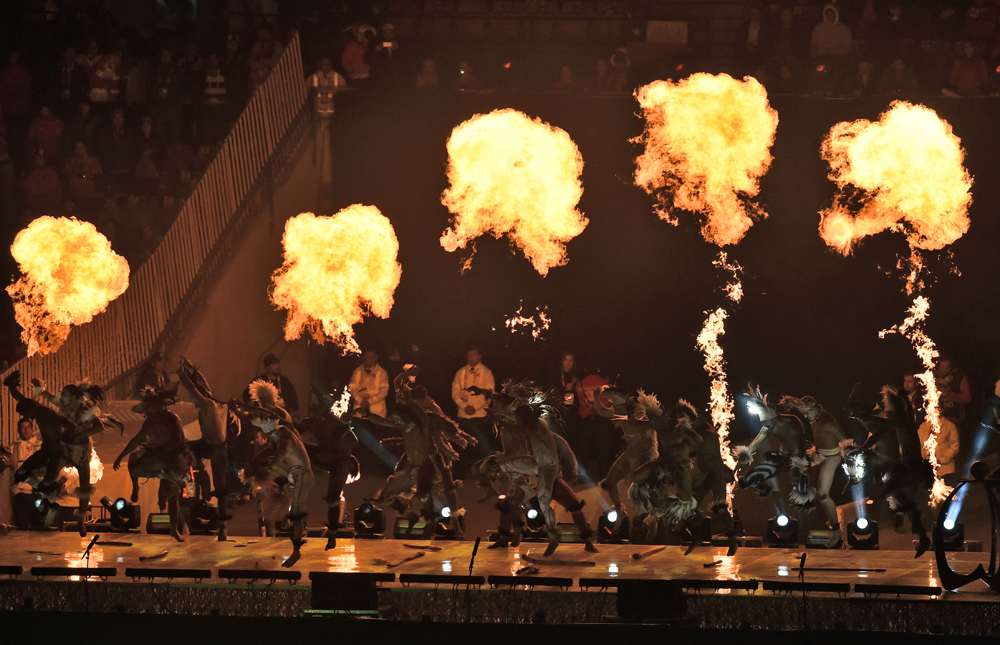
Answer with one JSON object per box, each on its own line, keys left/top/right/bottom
{"left": 324, "top": 93, "right": 1000, "bottom": 442}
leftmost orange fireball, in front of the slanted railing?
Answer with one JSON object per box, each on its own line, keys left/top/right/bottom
{"left": 7, "top": 216, "right": 129, "bottom": 356}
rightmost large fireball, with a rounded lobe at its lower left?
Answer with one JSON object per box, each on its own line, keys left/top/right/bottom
{"left": 819, "top": 101, "right": 972, "bottom": 255}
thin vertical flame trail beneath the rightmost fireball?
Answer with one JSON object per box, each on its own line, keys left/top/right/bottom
{"left": 879, "top": 296, "right": 951, "bottom": 506}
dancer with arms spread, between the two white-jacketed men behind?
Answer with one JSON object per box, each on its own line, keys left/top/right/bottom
{"left": 359, "top": 366, "right": 476, "bottom": 539}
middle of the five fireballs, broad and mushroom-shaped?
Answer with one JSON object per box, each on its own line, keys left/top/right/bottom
{"left": 441, "top": 109, "right": 588, "bottom": 276}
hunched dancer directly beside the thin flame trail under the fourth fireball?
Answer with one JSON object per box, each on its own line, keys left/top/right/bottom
{"left": 666, "top": 399, "right": 737, "bottom": 556}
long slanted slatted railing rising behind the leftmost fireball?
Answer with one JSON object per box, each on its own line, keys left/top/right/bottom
{"left": 0, "top": 34, "right": 311, "bottom": 445}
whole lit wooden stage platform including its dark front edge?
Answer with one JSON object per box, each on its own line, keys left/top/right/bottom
{"left": 0, "top": 532, "right": 1000, "bottom": 635}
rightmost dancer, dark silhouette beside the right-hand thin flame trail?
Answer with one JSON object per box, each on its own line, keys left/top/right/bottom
{"left": 842, "top": 385, "right": 934, "bottom": 558}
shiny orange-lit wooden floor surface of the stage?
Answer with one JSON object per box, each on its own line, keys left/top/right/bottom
{"left": 0, "top": 531, "right": 1000, "bottom": 603}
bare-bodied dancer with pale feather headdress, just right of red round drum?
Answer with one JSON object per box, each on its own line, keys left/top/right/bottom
{"left": 594, "top": 385, "right": 660, "bottom": 532}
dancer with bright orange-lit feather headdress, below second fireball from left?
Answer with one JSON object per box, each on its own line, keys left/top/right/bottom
{"left": 229, "top": 379, "right": 315, "bottom": 567}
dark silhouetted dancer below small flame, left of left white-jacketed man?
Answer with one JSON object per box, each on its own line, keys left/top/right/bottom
{"left": 299, "top": 393, "right": 361, "bottom": 551}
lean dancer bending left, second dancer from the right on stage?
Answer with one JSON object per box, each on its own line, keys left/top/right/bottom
{"left": 779, "top": 396, "right": 846, "bottom": 549}
